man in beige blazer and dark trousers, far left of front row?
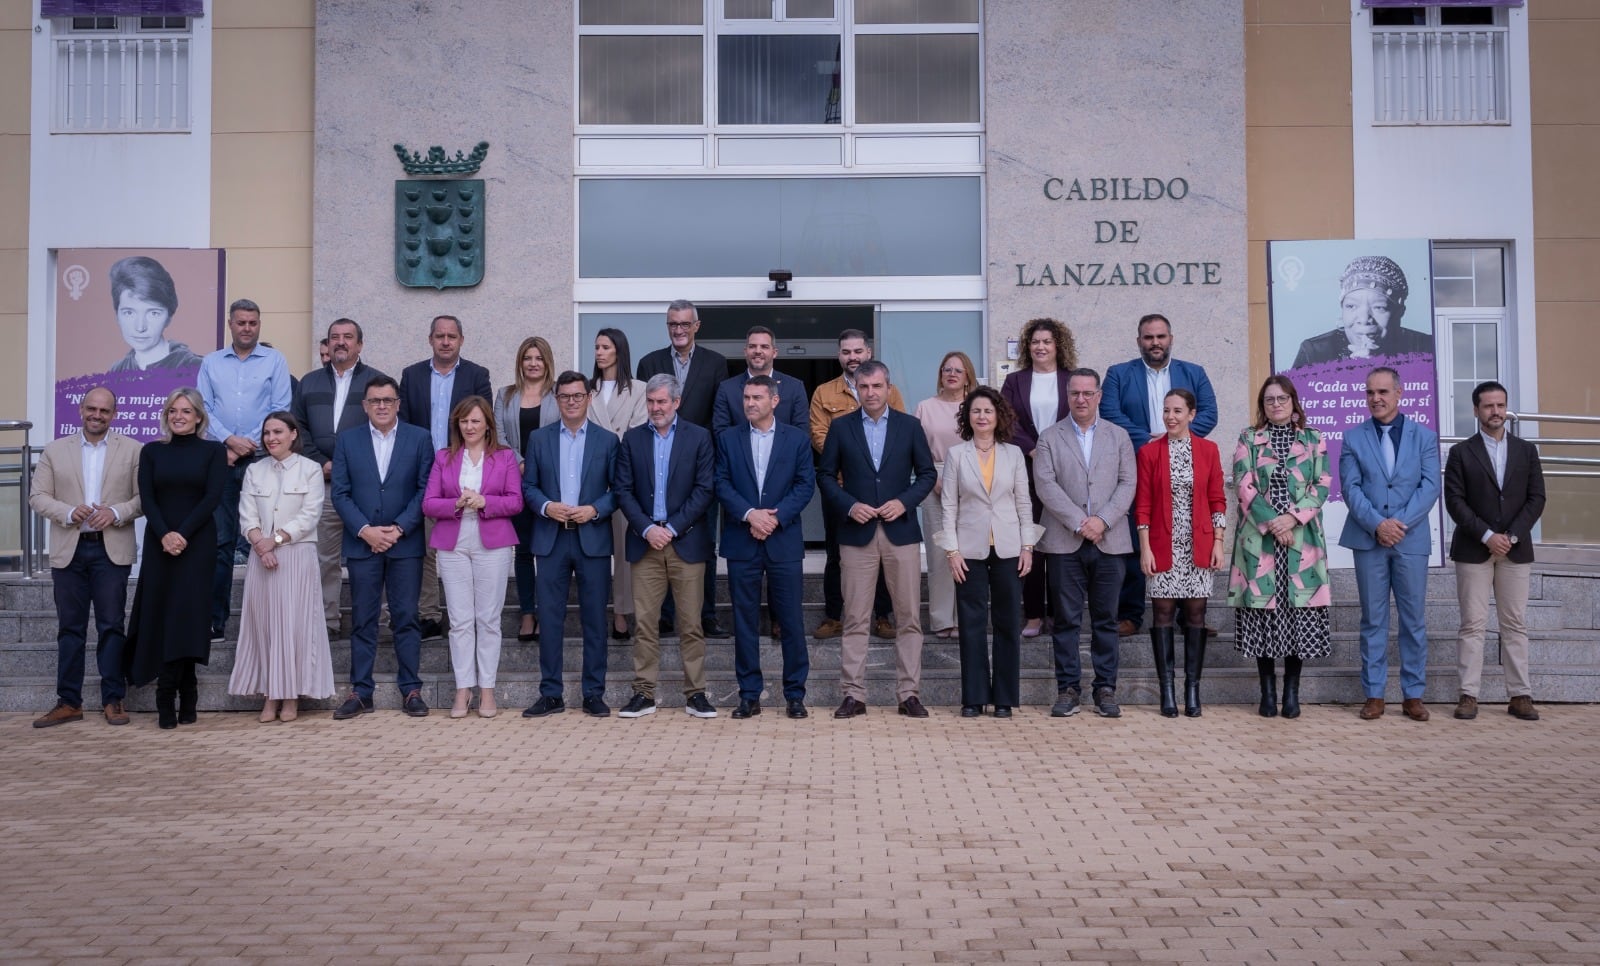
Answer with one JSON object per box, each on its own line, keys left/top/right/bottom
{"left": 27, "top": 387, "right": 141, "bottom": 728}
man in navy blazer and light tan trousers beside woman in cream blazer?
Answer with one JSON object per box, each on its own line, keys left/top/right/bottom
{"left": 816, "top": 361, "right": 936, "bottom": 718}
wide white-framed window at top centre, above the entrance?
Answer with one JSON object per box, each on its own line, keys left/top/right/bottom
{"left": 578, "top": 0, "right": 982, "bottom": 130}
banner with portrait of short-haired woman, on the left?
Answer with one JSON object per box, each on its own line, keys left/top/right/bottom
{"left": 53, "top": 248, "right": 226, "bottom": 443}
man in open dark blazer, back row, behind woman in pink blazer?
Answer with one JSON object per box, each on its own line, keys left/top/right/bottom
{"left": 400, "top": 315, "right": 494, "bottom": 641}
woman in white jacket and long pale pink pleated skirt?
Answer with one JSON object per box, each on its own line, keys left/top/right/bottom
{"left": 227, "top": 411, "right": 333, "bottom": 723}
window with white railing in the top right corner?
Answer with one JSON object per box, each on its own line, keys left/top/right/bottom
{"left": 1370, "top": 5, "right": 1510, "bottom": 125}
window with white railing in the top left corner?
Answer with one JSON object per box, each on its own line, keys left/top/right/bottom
{"left": 51, "top": 16, "right": 192, "bottom": 133}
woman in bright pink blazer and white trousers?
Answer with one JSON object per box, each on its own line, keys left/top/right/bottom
{"left": 422, "top": 395, "right": 522, "bottom": 718}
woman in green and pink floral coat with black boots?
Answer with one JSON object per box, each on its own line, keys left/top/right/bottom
{"left": 1227, "top": 376, "right": 1333, "bottom": 718}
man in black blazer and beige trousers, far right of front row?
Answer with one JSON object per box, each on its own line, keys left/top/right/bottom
{"left": 1445, "top": 382, "right": 1544, "bottom": 721}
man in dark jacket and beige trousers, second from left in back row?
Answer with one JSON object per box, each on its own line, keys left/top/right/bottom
{"left": 291, "top": 318, "right": 382, "bottom": 638}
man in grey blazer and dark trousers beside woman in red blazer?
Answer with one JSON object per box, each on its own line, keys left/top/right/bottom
{"left": 1034, "top": 369, "right": 1139, "bottom": 718}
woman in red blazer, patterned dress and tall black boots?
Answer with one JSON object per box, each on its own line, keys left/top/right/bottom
{"left": 1133, "top": 389, "right": 1227, "bottom": 718}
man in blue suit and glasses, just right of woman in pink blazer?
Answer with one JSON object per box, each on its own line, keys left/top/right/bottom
{"left": 522, "top": 369, "right": 616, "bottom": 718}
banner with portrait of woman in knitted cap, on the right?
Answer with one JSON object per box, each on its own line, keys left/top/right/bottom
{"left": 1267, "top": 238, "right": 1440, "bottom": 566}
